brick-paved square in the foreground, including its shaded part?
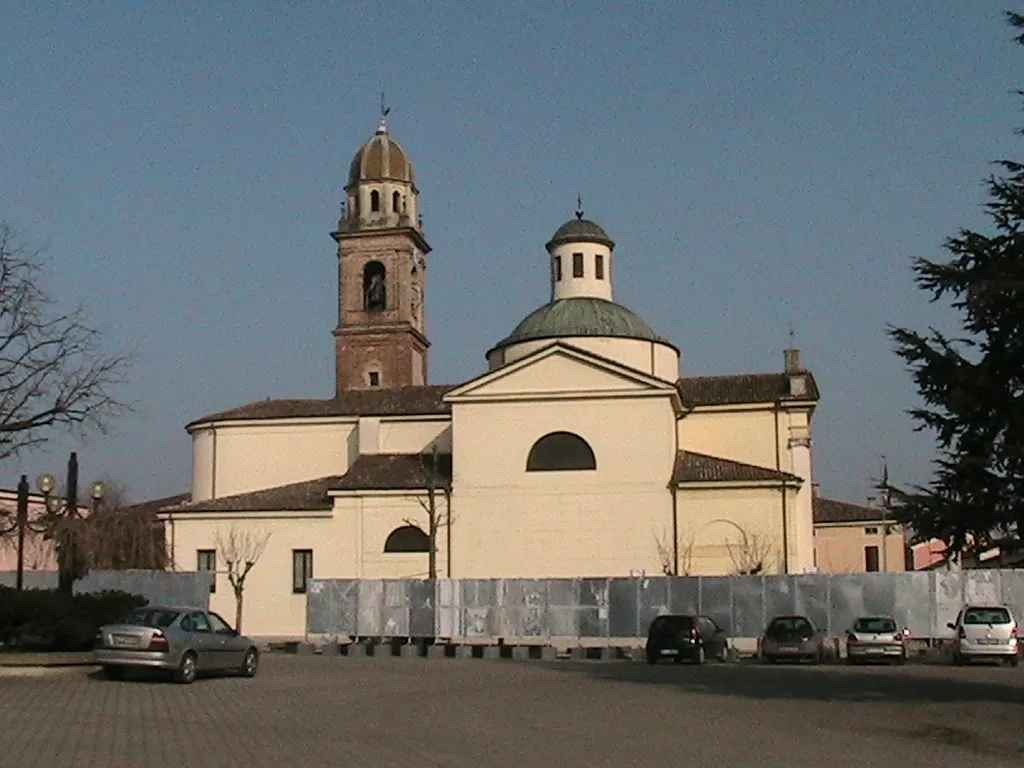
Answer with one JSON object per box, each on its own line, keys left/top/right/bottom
{"left": 0, "top": 655, "right": 1024, "bottom": 768}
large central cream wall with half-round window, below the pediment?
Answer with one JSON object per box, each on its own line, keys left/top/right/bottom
{"left": 452, "top": 395, "right": 675, "bottom": 578}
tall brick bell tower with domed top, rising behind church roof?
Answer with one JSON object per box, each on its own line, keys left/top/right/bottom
{"left": 331, "top": 112, "right": 430, "bottom": 393}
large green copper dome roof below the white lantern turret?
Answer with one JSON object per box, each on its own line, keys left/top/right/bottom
{"left": 495, "top": 297, "right": 671, "bottom": 349}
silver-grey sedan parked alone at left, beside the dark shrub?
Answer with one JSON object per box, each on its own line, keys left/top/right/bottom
{"left": 94, "top": 606, "right": 259, "bottom": 684}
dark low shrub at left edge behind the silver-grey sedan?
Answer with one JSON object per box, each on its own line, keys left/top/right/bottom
{"left": 0, "top": 587, "right": 147, "bottom": 650}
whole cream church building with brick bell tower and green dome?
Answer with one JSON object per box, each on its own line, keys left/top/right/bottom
{"left": 162, "top": 121, "right": 818, "bottom": 637}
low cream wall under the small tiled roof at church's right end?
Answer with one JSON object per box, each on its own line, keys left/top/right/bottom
{"left": 677, "top": 487, "right": 799, "bottom": 575}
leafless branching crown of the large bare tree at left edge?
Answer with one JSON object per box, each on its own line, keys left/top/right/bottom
{"left": 0, "top": 223, "right": 129, "bottom": 460}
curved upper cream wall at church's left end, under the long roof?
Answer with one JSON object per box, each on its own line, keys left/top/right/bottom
{"left": 193, "top": 419, "right": 356, "bottom": 501}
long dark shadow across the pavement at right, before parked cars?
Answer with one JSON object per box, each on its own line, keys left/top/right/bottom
{"left": 551, "top": 662, "right": 1024, "bottom": 714}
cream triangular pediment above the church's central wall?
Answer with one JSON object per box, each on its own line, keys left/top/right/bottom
{"left": 444, "top": 342, "right": 677, "bottom": 402}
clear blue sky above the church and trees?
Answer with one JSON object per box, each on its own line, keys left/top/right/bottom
{"left": 0, "top": 0, "right": 1024, "bottom": 502}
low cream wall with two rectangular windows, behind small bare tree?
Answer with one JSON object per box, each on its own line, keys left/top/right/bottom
{"left": 166, "top": 514, "right": 337, "bottom": 637}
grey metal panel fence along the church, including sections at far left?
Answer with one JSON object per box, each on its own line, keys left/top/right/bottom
{"left": 303, "top": 570, "right": 1024, "bottom": 642}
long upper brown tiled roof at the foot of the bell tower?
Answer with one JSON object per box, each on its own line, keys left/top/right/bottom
{"left": 188, "top": 385, "right": 455, "bottom": 427}
